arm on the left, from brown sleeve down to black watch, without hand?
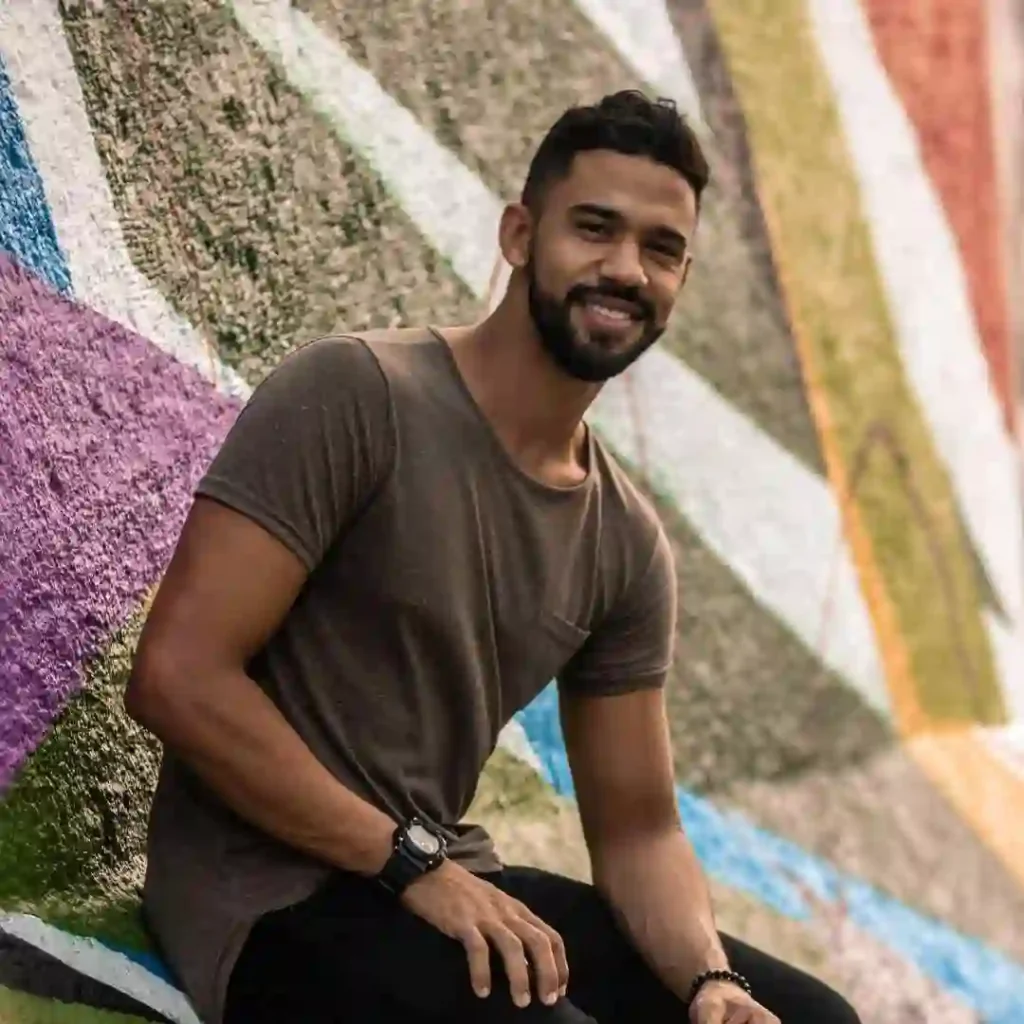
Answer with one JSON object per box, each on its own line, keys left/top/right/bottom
{"left": 126, "top": 337, "right": 403, "bottom": 873}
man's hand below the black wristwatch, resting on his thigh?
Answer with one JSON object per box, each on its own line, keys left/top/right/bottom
{"left": 401, "top": 861, "right": 569, "bottom": 1007}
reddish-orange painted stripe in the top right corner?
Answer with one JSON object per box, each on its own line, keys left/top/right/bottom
{"left": 861, "top": 0, "right": 1016, "bottom": 430}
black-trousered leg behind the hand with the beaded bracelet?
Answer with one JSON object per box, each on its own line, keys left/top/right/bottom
{"left": 502, "top": 867, "right": 859, "bottom": 1024}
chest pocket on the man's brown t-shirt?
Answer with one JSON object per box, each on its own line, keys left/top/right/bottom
{"left": 497, "top": 607, "right": 590, "bottom": 715}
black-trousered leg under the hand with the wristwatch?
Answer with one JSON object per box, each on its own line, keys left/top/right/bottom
{"left": 225, "top": 873, "right": 595, "bottom": 1024}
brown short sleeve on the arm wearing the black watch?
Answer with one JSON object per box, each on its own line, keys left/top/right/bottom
{"left": 197, "top": 338, "right": 394, "bottom": 571}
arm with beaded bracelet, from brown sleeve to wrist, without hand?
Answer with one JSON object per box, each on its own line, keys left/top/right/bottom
{"left": 558, "top": 525, "right": 728, "bottom": 996}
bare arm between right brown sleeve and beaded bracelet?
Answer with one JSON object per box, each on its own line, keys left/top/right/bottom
{"left": 561, "top": 688, "right": 728, "bottom": 998}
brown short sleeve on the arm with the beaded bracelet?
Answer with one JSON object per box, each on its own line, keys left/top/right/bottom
{"left": 558, "top": 526, "right": 677, "bottom": 696}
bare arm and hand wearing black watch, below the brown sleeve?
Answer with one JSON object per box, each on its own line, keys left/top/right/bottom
{"left": 125, "top": 498, "right": 568, "bottom": 1006}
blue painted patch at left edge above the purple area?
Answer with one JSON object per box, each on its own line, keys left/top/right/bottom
{"left": 0, "top": 60, "right": 72, "bottom": 295}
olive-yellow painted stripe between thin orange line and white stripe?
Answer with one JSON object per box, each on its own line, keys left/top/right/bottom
{"left": 710, "top": 0, "right": 1004, "bottom": 724}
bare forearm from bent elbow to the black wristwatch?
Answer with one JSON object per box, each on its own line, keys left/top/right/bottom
{"left": 126, "top": 671, "right": 395, "bottom": 874}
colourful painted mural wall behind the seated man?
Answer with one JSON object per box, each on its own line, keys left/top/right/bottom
{"left": 0, "top": 0, "right": 1024, "bottom": 1024}
